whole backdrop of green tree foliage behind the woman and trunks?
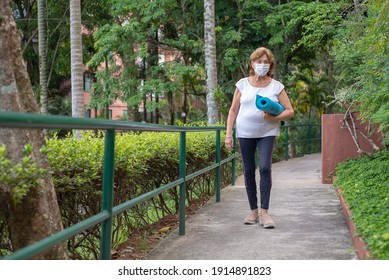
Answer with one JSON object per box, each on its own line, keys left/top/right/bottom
{"left": 11, "top": 0, "right": 389, "bottom": 135}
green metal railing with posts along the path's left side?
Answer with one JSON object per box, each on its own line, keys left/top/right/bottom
{"left": 0, "top": 112, "right": 237, "bottom": 260}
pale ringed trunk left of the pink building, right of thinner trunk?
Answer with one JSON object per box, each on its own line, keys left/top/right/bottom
{"left": 70, "top": 0, "right": 84, "bottom": 123}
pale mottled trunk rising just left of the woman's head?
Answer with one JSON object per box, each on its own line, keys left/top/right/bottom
{"left": 204, "top": 0, "right": 219, "bottom": 124}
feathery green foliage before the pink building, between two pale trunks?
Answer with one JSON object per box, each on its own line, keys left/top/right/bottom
{"left": 89, "top": 0, "right": 204, "bottom": 124}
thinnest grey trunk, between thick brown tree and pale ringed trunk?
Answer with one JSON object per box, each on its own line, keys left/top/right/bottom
{"left": 38, "top": 0, "right": 48, "bottom": 114}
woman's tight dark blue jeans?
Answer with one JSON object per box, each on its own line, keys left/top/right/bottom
{"left": 239, "top": 136, "right": 276, "bottom": 210}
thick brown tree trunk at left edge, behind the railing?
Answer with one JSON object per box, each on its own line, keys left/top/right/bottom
{"left": 0, "top": 1, "right": 67, "bottom": 259}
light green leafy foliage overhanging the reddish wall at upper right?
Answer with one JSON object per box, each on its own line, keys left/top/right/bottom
{"left": 332, "top": 1, "right": 389, "bottom": 144}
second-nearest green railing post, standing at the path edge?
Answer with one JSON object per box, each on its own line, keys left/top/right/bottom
{"left": 178, "top": 131, "right": 186, "bottom": 235}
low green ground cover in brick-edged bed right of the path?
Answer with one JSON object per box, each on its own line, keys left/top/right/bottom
{"left": 334, "top": 151, "right": 389, "bottom": 259}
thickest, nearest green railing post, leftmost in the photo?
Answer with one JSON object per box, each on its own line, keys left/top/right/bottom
{"left": 100, "top": 129, "right": 115, "bottom": 260}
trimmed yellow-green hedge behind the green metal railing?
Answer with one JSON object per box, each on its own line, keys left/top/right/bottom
{"left": 47, "top": 132, "right": 231, "bottom": 259}
